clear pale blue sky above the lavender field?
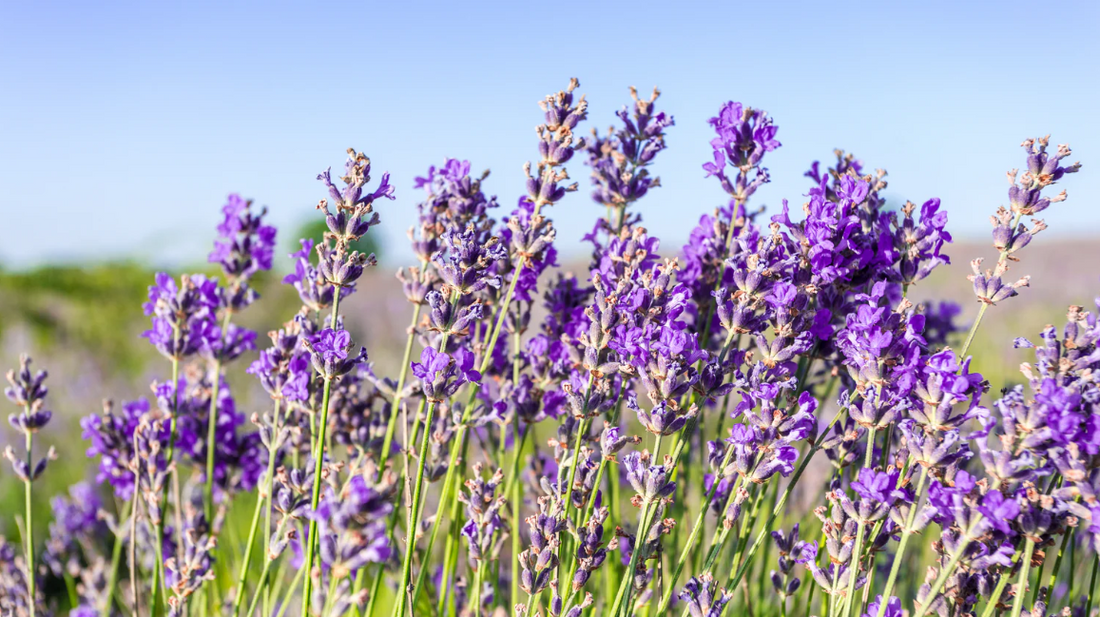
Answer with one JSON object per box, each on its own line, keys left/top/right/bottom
{"left": 0, "top": 1, "right": 1100, "bottom": 265}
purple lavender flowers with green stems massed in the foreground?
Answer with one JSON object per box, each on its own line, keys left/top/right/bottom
{"left": 0, "top": 79, "right": 1100, "bottom": 617}
